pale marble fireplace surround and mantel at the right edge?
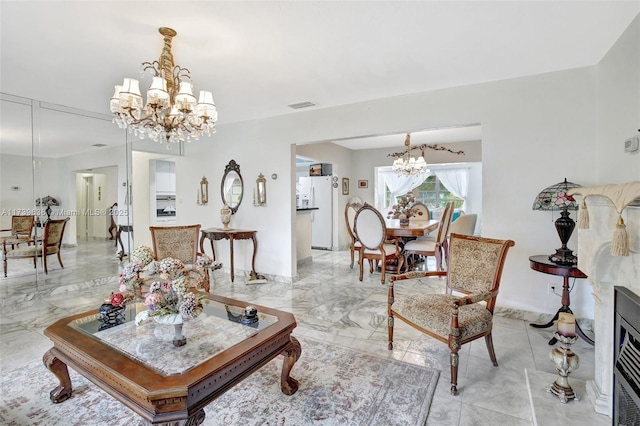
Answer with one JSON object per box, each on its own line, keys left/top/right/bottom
{"left": 569, "top": 181, "right": 640, "bottom": 417}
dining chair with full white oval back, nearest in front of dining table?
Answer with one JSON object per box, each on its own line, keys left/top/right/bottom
{"left": 354, "top": 203, "right": 404, "bottom": 285}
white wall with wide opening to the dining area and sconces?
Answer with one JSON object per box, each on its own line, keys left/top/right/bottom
{"left": 172, "top": 58, "right": 612, "bottom": 317}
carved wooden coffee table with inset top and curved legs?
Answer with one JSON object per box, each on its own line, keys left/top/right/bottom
{"left": 43, "top": 293, "right": 301, "bottom": 425}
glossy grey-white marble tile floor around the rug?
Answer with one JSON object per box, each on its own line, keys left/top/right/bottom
{"left": 0, "top": 241, "right": 611, "bottom": 426}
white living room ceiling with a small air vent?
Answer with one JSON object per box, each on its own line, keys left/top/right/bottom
{"left": 0, "top": 0, "right": 640, "bottom": 152}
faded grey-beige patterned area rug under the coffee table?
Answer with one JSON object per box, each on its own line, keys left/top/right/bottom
{"left": 0, "top": 337, "right": 439, "bottom": 426}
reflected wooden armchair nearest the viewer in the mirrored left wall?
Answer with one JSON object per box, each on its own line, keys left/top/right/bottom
{"left": 2, "top": 216, "right": 69, "bottom": 277}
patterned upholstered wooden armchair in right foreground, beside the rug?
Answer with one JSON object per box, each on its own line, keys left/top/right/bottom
{"left": 388, "top": 234, "right": 515, "bottom": 395}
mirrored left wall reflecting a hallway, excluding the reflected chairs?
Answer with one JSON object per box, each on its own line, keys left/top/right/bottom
{"left": 0, "top": 93, "right": 132, "bottom": 291}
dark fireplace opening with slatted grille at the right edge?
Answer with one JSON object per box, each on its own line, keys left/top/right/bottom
{"left": 613, "top": 286, "right": 640, "bottom": 426}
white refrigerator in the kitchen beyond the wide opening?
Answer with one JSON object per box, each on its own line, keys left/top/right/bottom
{"left": 299, "top": 176, "right": 333, "bottom": 250}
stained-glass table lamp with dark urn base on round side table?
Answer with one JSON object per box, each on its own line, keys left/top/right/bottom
{"left": 533, "top": 178, "right": 580, "bottom": 265}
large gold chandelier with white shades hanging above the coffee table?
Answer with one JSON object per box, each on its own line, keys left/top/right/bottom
{"left": 110, "top": 27, "right": 218, "bottom": 149}
